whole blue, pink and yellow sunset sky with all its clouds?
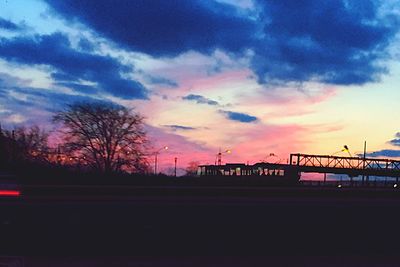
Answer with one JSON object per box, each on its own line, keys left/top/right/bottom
{"left": 0, "top": 0, "right": 400, "bottom": 172}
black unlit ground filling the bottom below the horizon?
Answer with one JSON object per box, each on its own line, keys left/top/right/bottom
{"left": 0, "top": 187, "right": 400, "bottom": 266}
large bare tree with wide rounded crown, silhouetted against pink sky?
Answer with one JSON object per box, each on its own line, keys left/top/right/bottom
{"left": 53, "top": 102, "right": 147, "bottom": 172}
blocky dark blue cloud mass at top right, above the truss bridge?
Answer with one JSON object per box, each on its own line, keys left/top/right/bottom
{"left": 252, "top": 0, "right": 399, "bottom": 85}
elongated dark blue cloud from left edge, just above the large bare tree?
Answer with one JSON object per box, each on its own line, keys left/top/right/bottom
{"left": 0, "top": 33, "right": 147, "bottom": 99}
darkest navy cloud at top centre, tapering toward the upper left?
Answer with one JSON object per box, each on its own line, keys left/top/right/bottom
{"left": 47, "top": 0, "right": 254, "bottom": 56}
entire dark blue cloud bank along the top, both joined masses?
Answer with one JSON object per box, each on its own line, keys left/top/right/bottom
{"left": 37, "top": 0, "right": 399, "bottom": 85}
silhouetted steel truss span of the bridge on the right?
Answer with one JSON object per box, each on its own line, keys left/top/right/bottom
{"left": 290, "top": 154, "right": 400, "bottom": 172}
